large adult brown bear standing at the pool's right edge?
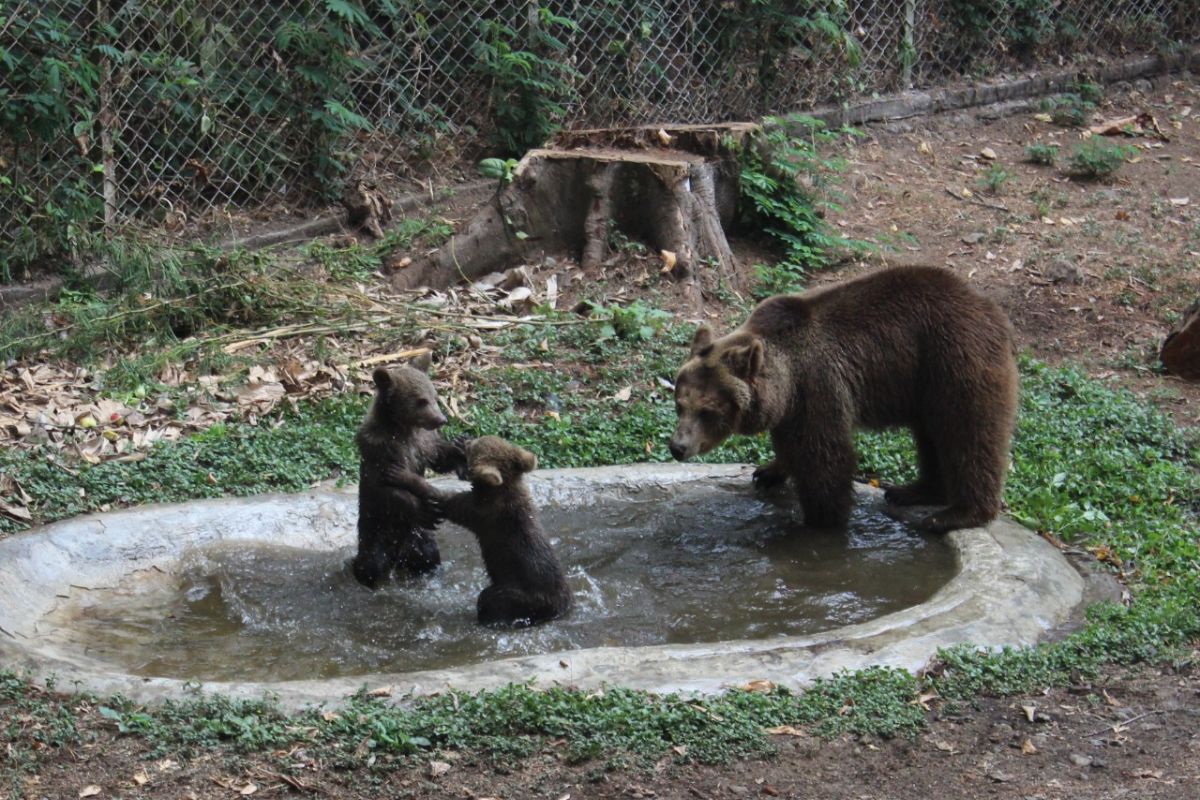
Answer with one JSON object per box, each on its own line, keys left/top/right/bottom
{"left": 671, "top": 266, "right": 1018, "bottom": 531}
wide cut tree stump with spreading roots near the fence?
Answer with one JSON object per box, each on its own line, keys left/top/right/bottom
{"left": 392, "top": 122, "right": 758, "bottom": 308}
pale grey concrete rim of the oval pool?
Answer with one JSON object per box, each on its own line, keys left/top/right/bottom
{"left": 0, "top": 464, "right": 1109, "bottom": 708}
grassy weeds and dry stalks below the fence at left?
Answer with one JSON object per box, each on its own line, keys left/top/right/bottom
{"left": 0, "top": 217, "right": 451, "bottom": 372}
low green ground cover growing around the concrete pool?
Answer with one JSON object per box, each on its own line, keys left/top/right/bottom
{"left": 0, "top": 313, "right": 1200, "bottom": 766}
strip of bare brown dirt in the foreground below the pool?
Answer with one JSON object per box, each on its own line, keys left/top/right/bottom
{"left": 23, "top": 652, "right": 1200, "bottom": 800}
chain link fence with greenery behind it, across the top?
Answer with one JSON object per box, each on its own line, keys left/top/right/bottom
{"left": 0, "top": 0, "right": 1200, "bottom": 277}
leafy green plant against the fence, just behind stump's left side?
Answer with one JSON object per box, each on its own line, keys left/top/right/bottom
{"left": 475, "top": 7, "right": 578, "bottom": 155}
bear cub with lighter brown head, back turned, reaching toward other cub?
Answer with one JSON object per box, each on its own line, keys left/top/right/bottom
{"left": 388, "top": 437, "right": 571, "bottom": 626}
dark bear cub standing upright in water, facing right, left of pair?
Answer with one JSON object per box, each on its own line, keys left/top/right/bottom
{"left": 350, "top": 353, "right": 467, "bottom": 589}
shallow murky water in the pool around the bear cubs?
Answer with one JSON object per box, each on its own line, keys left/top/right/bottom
{"left": 54, "top": 487, "right": 955, "bottom": 681}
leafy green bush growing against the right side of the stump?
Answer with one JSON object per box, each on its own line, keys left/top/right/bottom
{"left": 737, "top": 116, "right": 856, "bottom": 296}
